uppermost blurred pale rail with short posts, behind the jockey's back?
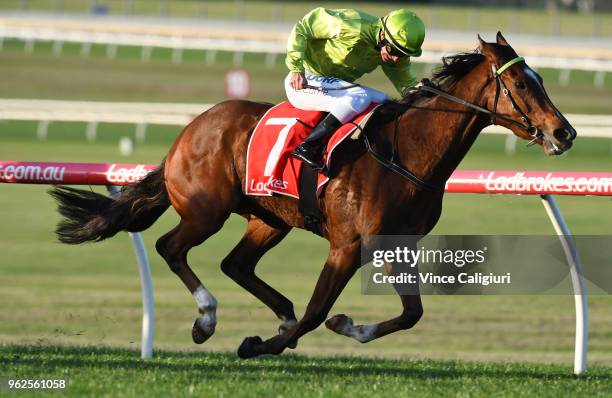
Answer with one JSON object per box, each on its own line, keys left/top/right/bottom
{"left": 0, "top": 15, "right": 612, "bottom": 74}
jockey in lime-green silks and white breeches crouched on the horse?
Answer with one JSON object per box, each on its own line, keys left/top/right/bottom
{"left": 285, "top": 7, "right": 425, "bottom": 169}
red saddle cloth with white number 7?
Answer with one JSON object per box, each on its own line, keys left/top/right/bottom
{"left": 244, "top": 101, "right": 378, "bottom": 198}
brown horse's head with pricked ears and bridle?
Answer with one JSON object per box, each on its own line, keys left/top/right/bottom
{"left": 478, "top": 32, "right": 576, "bottom": 155}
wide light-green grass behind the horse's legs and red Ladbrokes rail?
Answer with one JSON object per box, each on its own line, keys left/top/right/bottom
{"left": 0, "top": 136, "right": 612, "bottom": 366}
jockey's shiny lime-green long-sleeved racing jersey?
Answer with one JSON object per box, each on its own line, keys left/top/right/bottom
{"left": 285, "top": 7, "right": 417, "bottom": 94}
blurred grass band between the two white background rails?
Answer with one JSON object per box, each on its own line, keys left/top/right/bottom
{"left": 0, "top": 40, "right": 612, "bottom": 114}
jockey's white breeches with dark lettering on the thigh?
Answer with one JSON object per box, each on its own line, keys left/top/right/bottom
{"left": 285, "top": 73, "right": 388, "bottom": 123}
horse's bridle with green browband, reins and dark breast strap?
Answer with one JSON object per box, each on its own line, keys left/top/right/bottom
{"left": 363, "top": 57, "right": 544, "bottom": 192}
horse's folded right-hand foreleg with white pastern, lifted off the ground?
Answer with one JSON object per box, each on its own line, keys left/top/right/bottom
{"left": 325, "top": 266, "right": 423, "bottom": 343}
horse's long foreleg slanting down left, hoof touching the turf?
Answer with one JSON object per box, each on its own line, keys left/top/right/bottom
{"left": 238, "top": 242, "right": 360, "bottom": 358}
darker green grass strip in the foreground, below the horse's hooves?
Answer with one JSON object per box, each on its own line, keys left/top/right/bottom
{"left": 0, "top": 345, "right": 612, "bottom": 398}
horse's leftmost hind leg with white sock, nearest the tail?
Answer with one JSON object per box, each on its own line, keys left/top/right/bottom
{"left": 155, "top": 217, "right": 227, "bottom": 344}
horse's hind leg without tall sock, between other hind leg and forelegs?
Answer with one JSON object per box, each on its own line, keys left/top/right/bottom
{"left": 221, "top": 216, "right": 296, "bottom": 340}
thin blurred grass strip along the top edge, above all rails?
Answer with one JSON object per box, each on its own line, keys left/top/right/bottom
{"left": 0, "top": 0, "right": 612, "bottom": 36}
